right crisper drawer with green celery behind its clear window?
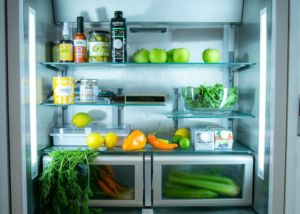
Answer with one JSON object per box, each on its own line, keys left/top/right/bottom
{"left": 153, "top": 155, "right": 253, "bottom": 206}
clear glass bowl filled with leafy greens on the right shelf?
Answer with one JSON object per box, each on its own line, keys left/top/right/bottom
{"left": 181, "top": 84, "right": 238, "bottom": 110}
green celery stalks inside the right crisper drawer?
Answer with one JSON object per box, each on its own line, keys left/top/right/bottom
{"left": 163, "top": 170, "right": 240, "bottom": 199}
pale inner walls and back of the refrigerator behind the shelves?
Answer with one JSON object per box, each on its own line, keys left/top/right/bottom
{"left": 12, "top": 0, "right": 286, "bottom": 213}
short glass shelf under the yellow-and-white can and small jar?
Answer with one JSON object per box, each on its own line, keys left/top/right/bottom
{"left": 41, "top": 102, "right": 165, "bottom": 107}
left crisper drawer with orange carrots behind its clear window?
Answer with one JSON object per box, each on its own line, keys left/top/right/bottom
{"left": 43, "top": 155, "right": 143, "bottom": 207}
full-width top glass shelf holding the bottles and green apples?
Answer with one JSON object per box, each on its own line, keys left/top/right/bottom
{"left": 40, "top": 62, "right": 256, "bottom": 71}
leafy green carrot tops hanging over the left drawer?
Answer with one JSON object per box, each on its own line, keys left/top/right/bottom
{"left": 40, "top": 150, "right": 98, "bottom": 214}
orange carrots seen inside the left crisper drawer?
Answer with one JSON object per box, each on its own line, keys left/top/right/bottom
{"left": 91, "top": 165, "right": 134, "bottom": 200}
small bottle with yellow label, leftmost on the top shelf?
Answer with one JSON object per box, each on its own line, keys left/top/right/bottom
{"left": 59, "top": 22, "right": 74, "bottom": 62}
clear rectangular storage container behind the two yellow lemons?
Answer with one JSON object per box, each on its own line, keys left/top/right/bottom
{"left": 50, "top": 124, "right": 130, "bottom": 146}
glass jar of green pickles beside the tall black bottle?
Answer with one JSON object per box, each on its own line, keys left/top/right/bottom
{"left": 88, "top": 30, "right": 110, "bottom": 62}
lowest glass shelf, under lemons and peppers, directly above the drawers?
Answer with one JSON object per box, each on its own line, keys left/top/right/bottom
{"left": 44, "top": 142, "right": 252, "bottom": 155}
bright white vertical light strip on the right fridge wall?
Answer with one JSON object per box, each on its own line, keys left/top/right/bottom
{"left": 258, "top": 8, "right": 268, "bottom": 179}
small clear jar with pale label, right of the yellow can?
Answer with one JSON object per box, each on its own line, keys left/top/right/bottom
{"left": 80, "top": 79, "right": 98, "bottom": 103}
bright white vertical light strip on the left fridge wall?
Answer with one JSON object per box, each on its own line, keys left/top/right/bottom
{"left": 28, "top": 7, "right": 37, "bottom": 178}
